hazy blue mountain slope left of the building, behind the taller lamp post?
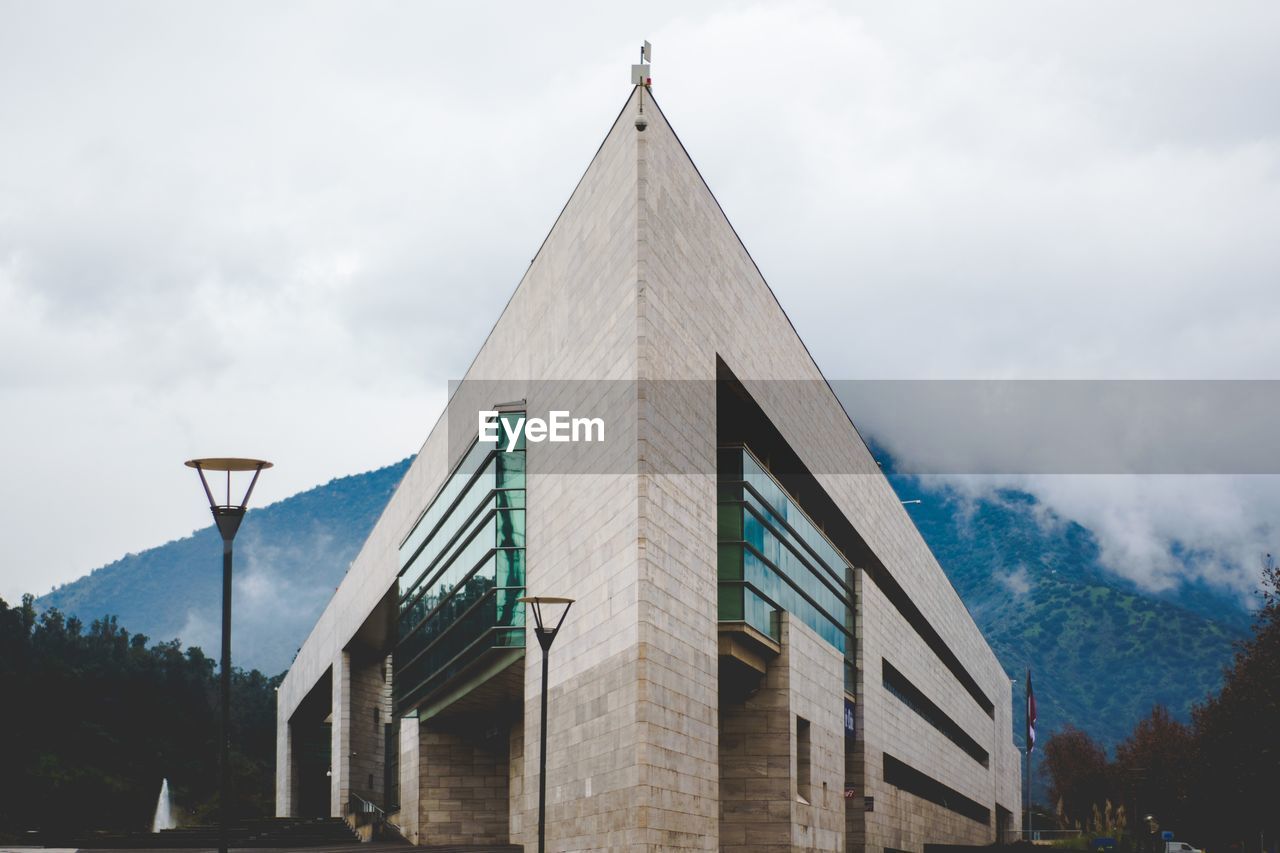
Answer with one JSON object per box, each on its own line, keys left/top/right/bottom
{"left": 36, "top": 459, "right": 411, "bottom": 675}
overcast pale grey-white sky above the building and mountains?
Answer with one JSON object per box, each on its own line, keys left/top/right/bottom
{"left": 0, "top": 0, "right": 1280, "bottom": 599}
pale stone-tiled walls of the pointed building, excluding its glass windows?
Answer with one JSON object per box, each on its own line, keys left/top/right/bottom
{"left": 276, "top": 83, "right": 1021, "bottom": 853}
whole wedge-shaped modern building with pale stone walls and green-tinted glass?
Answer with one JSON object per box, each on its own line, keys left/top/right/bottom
{"left": 276, "top": 88, "right": 1021, "bottom": 850}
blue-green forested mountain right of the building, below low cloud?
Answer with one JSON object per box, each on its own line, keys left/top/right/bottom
{"left": 890, "top": 475, "right": 1249, "bottom": 747}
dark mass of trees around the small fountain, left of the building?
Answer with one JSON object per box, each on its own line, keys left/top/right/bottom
{"left": 0, "top": 596, "right": 279, "bottom": 841}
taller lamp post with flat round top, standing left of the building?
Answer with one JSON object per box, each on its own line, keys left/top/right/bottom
{"left": 186, "top": 457, "right": 271, "bottom": 853}
